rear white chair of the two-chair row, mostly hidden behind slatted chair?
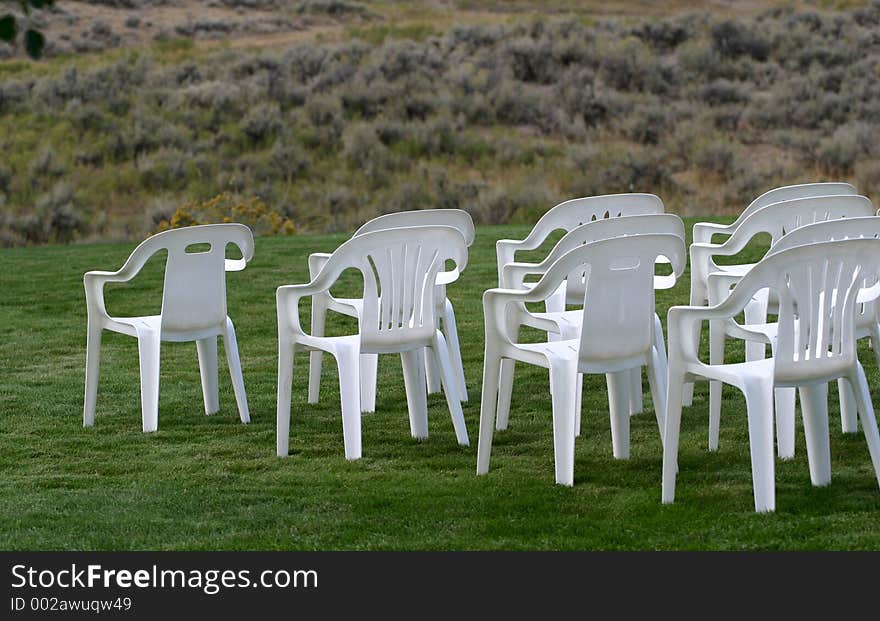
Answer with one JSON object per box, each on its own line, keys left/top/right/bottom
{"left": 309, "top": 209, "right": 474, "bottom": 412}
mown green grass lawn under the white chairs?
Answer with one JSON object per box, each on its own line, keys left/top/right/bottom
{"left": 0, "top": 221, "right": 880, "bottom": 550}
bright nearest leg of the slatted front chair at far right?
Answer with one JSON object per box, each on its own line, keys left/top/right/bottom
{"left": 744, "top": 378, "right": 776, "bottom": 513}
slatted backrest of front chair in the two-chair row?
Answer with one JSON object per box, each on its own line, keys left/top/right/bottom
{"left": 328, "top": 226, "right": 467, "bottom": 352}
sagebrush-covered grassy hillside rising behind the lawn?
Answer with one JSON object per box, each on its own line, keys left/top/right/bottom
{"left": 0, "top": 0, "right": 880, "bottom": 246}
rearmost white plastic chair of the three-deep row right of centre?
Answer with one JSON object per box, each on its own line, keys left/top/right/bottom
{"left": 495, "top": 193, "right": 664, "bottom": 422}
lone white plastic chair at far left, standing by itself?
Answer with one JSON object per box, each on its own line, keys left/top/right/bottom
{"left": 83, "top": 224, "right": 254, "bottom": 432}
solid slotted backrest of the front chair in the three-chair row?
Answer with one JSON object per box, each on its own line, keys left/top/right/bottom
{"left": 539, "top": 234, "right": 686, "bottom": 368}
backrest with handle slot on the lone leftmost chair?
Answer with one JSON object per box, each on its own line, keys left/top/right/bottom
{"left": 129, "top": 223, "right": 254, "bottom": 334}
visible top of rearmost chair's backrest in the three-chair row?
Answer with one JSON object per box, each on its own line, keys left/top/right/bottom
{"left": 526, "top": 194, "right": 664, "bottom": 247}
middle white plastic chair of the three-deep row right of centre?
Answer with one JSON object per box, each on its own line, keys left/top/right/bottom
{"left": 495, "top": 213, "right": 685, "bottom": 436}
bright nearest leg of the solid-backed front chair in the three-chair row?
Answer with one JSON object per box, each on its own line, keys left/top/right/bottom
{"left": 550, "top": 360, "right": 576, "bottom": 486}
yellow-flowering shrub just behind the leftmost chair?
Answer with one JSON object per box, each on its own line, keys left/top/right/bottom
{"left": 153, "top": 193, "right": 296, "bottom": 235}
